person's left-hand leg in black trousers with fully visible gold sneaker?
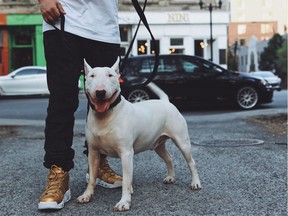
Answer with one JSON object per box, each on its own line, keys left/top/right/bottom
{"left": 38, "top": 31, "right": 83, "bottom": 209}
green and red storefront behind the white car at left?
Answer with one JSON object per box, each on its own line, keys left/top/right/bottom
{"left": 0, "top": 14, "right": 46, "bottom": 75}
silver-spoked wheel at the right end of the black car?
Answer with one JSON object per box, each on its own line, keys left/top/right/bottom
{"left": 236, "top": 86, "right": 258, "bottom": 110}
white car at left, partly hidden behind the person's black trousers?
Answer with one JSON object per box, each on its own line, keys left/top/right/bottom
{"left": 0, "top": 66, "right": 81, "bottom": 96}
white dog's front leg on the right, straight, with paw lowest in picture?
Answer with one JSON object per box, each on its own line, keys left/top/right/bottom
{"left": 113, "top": 149, "right": 134, "bottom": 211}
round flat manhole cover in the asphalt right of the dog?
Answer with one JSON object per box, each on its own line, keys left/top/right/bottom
{"left": 194, "top": 139, "right": 264, "bottom": 147}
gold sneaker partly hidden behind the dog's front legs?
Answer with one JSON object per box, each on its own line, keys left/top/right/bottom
{"left": 86, "top": 159, "right": 122, "bottom": 188}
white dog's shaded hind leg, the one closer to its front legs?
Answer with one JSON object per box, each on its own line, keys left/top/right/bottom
{"left": 155, "top": 140, "right": 175, "bottom": 184}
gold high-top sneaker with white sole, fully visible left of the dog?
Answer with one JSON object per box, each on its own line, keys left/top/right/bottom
{"left": 38, "top": 165, "right": 71, "bottom": 210}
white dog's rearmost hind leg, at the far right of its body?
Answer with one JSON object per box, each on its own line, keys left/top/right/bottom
{"left": 172, "top": 134, "right": 201, "bottom": 190}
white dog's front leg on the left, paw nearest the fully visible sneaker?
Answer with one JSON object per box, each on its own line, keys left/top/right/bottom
{"left": 77, "top": 148, "right": 100, "bottom": 203}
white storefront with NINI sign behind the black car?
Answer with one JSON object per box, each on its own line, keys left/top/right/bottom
{"left": 119, "top": 11, "right": 229, "bottom": 67}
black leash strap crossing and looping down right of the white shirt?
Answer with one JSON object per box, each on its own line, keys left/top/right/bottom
{"left": 120, "top": 0, "right": 159, "bottom": 87}
